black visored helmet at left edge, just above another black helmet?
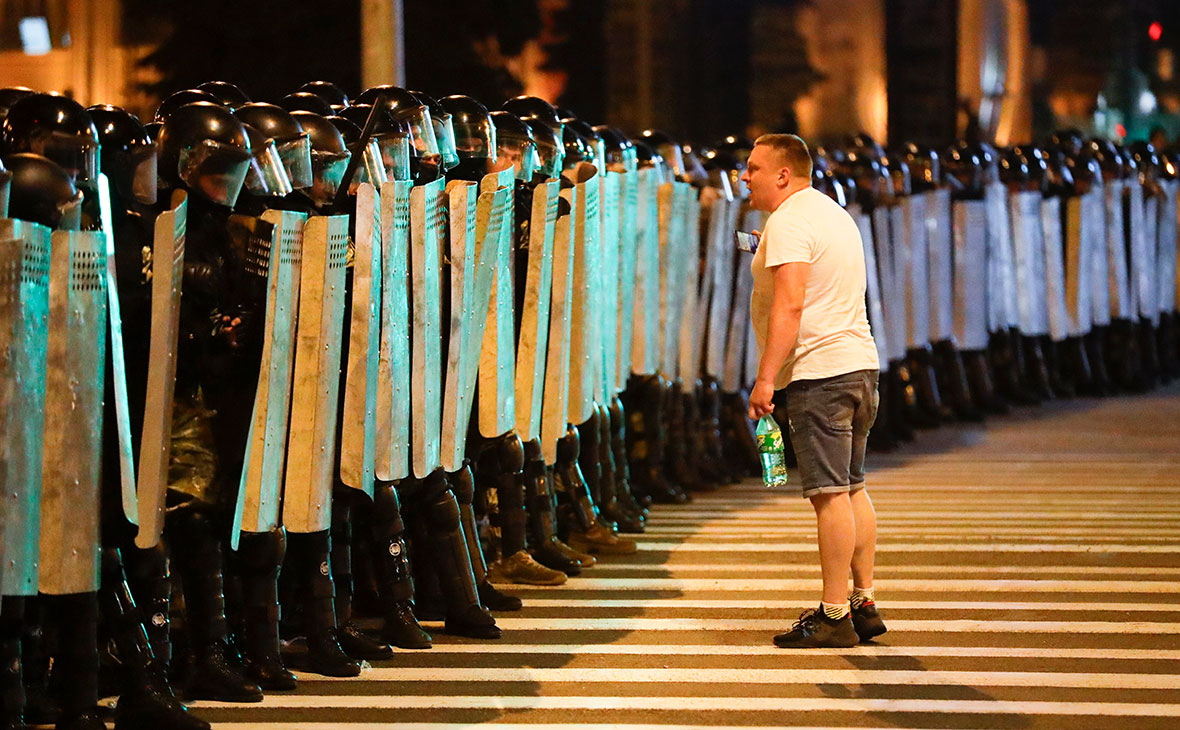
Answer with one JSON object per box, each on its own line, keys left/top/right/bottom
{"left": 0, "top": 94, "right": 98, "bottom": 186}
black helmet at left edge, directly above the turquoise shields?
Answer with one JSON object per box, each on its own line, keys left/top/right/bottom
{"left": 4, "top": 152, "right": 83, "bottom": 230}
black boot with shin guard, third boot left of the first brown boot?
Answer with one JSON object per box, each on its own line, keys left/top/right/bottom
{"left": 361, "top": 481, "right": 433, "bottom": 649}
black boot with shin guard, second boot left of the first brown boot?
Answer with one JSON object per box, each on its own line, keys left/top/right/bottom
{"left": 424, "top": 471, "right": 500, "bottom": 639}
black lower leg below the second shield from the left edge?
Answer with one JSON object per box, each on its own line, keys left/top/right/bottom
{"left": 44, "top": 593, "right": 106, "bottom": 730}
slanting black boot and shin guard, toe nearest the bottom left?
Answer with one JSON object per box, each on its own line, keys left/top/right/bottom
{"left": 99, "top": 547, "right": 209, "bottom": 730}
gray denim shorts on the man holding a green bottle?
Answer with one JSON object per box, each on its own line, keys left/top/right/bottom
{"left": 780, "top": 370, "right": 879, "bottom": 498}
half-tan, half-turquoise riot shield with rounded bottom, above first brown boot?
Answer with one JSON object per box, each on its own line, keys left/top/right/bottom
{"left": 474, "top": 167, "right": 516, "bottom": 439}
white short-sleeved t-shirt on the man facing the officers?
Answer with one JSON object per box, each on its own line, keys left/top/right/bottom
{"left": 750, "top": 188, "right": 879, "bottom": 389}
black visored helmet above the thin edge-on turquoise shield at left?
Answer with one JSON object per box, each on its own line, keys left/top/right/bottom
{"left": 86, "top": 104, "right": 157, "bottom": 205}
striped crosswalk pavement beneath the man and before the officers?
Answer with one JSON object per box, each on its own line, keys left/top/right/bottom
{"left": 194, "top": 388, "right": 1180, "bottom": 730}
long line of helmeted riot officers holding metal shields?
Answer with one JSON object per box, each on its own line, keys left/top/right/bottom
{"left": 0, "top": 75, "right": 1180, "bottom": 730}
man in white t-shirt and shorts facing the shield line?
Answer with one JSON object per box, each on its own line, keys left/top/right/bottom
{"left": 742, "top": 134, "right": 885, "bottom": 647}
